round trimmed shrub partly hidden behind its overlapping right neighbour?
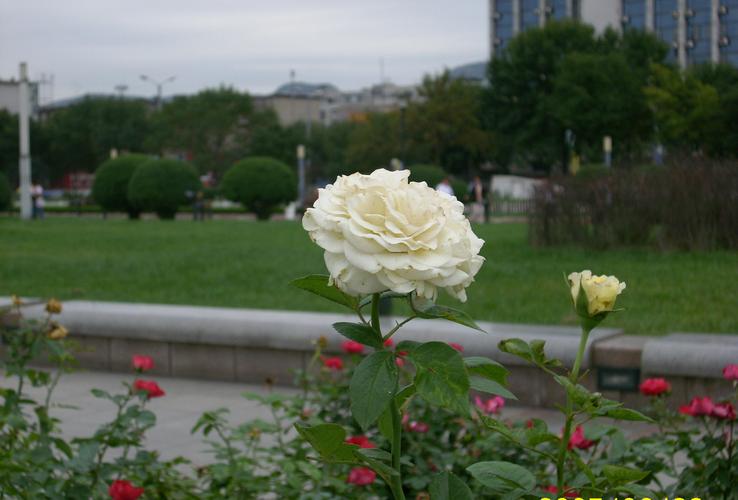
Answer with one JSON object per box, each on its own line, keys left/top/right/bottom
{"left": 92, "top": 154, "right": 150, "bottom": 219}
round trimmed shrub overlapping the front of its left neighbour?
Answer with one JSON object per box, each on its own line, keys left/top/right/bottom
{"left": 128, "top": 159, "right": 200, "bottom": 219}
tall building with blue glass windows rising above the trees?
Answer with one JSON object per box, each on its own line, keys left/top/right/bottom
{"left": 489, "top": 0, "right": 738, "bottom": 68}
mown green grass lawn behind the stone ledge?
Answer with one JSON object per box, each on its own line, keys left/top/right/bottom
{"left": 0, "top": 217, "right": 738, "bottom": 334}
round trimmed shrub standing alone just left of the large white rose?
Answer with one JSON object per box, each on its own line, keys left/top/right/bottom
{"left": 221, "top": 156, "right": 297, "bottom": 220}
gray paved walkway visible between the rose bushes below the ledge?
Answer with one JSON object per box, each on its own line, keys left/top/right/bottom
{"left": 0, "top": 371, "right": 647, "bottom": 464}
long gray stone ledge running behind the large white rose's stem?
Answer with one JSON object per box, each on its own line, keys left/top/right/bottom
{"left": 12, "top": 301, "right": 620, "bottom": 368}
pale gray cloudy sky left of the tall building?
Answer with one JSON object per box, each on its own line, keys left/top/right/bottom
{"left": 0, "top": 0, "right": 488, "bottom": 99}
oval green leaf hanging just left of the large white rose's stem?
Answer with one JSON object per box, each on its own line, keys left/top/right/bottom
{"left": 349, "top": 351, "right": 398, "bottom": 430}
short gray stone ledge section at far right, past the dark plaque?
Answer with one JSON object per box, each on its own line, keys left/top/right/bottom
{"left": 641, "top": 333, "right": 738, "bottom": 378}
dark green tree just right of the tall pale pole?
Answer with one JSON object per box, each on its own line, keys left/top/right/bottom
{"left": 44, "top": 98, "right": 150, "bottom": 179}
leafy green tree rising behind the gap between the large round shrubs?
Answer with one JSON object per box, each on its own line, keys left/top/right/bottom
{"left": 152, "top": 87, "right": 253, "bottom": 173}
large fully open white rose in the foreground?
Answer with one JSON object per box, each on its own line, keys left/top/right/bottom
{"left": 302, "top": 169, "right": 484, "bottom": 302}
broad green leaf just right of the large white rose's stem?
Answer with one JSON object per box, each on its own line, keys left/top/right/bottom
{"left": 408, "top": 342, "right": 470, "bottom": 415}
